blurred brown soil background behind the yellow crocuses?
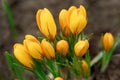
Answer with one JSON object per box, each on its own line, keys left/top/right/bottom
{"left": 0, "top": 0, "right": 120, "bottom": 80}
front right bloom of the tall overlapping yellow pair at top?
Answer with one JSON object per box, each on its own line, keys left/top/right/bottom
{"left": 70, "top": 5, "right": 87, "bottom": 34}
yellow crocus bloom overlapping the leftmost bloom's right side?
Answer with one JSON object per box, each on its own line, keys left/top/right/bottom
{"left": 24, "top": 35, "right": 43, "bottom": 60}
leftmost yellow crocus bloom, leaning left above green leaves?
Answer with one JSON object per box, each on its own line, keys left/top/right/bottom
{"left": 14, "top": 43, "right": 34, "bottom": 69}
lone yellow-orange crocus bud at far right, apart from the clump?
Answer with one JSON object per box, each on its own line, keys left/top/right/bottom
{"left": 103, "top": 33, "right": 114, "bottom": 51}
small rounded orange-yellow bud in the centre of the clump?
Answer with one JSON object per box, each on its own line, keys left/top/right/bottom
{"left": 56, "top": 40, "right": 69, "bottom": 56}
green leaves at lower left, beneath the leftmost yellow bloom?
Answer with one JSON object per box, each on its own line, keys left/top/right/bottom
{"left": 5, "top": 52, "right": 25, "bottom": 80}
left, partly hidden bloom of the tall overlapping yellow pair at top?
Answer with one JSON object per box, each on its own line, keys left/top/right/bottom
{"left": 59, "top": 6, "right": 76, "bottom": 36}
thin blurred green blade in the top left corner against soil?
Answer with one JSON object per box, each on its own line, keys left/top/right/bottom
{"left": 2, "top": 0, "right": 17, "bottom": 38}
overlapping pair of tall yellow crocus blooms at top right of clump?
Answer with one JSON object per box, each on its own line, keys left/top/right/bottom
{"left": 59, "top": 5, "right": 87, "bottom": 36}
